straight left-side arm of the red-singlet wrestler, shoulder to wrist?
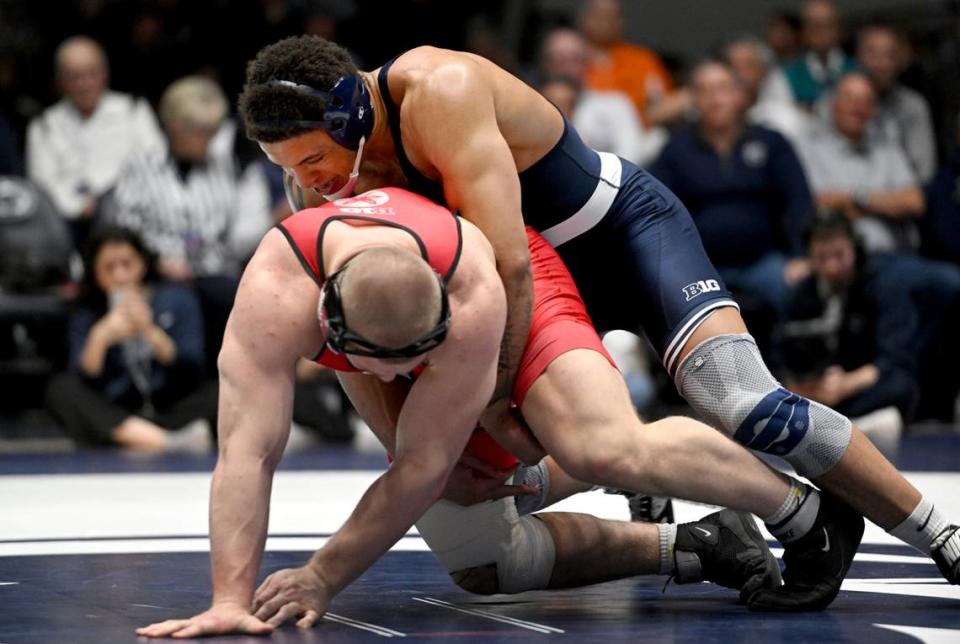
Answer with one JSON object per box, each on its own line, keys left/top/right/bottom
{"left": 210, "top": 233, "right": 324, "bottom": 610}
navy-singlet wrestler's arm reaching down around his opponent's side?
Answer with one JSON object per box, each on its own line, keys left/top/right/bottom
{"left": 404, "top": 64, "right": 533, "bottom": 402}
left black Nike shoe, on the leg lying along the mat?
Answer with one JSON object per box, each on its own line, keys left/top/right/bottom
{"left": 673, "top": 510, "right": 780, "bottom": 601}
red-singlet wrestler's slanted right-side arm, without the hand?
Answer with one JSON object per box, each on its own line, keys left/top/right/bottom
{"left": 311, "top": 274, "right": 506, "bottom": 596}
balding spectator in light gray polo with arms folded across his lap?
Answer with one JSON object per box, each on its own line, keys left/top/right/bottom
{"left": 800, "top": 73, "right": 925, "bottom": 252}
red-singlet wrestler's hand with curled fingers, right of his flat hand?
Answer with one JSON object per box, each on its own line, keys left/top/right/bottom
{"left": 253, "top": 564, "right": 331, "bottom": 628}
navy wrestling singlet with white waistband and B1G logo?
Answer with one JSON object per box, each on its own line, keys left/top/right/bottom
{"left": 378, "top": 59, "right": 736, "bottom": 374}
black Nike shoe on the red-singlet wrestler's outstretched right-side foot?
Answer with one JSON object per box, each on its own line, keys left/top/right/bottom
{"left": 747, "top": 492, "right": 863, "bottom": 612}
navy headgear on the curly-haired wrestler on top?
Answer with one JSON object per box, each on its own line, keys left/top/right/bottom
{"left": 259, "top": 76, "right": 373, "bottom": 150}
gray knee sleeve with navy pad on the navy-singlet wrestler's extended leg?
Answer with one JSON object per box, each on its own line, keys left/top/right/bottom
{"left": 676, "top": 334, "right": 851, "bottom": 477}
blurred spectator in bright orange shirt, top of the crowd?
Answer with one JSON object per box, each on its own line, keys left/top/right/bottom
{"left": 578, "top": 0, "right": 690, "bottom": 127}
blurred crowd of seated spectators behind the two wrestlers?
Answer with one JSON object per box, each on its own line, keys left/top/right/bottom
{"left": 0, "top": 0, "right": 960, "bottom": 451}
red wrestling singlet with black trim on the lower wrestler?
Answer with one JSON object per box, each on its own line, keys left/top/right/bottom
{"left": 277, "top": 188, "right": 616, "bottom": 469}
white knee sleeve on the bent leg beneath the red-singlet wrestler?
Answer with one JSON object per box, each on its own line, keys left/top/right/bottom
{"left": 417, "top": 497, "right": 556, "bottom": 593}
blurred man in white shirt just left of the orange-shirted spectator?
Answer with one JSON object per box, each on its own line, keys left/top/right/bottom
{"left": 540, "top": 28, "right": 666, "bottom": 165}
